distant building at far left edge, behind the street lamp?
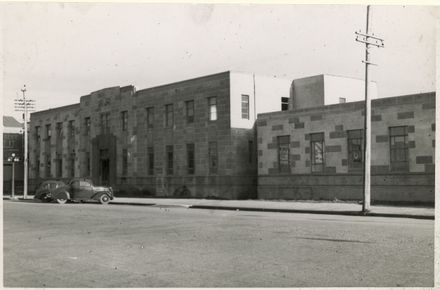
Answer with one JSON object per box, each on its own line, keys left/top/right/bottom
{"left": 3, "top": 116, "right": 24, "bottom": 193}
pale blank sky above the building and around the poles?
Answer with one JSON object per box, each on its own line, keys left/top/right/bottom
{"left": 0, "top": 3, "right": 439, "bottom": 121}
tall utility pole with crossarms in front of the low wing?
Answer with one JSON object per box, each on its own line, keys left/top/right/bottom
{"left": 355, "top": 5, "right": 384, "bottom": 212}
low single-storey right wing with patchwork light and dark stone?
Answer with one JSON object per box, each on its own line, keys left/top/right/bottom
{"left": 257, "top": 93, "right": 435, "bottom": 203}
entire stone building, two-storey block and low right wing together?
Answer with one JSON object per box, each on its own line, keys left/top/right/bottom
{"left": 29, "top": 71, "right": 435, "bottom": 203}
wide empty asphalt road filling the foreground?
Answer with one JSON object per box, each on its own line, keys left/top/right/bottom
{"left": 3, "top": 201, "right": 434, "bottom": 287}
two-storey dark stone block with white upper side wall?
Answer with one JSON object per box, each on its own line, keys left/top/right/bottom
{"left": 30, "top": 72, "right": 291, "bottom": 199}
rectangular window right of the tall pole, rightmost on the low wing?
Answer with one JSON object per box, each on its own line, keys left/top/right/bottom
{"left": 389, "top": 126, "right": 409, "bottom": 171}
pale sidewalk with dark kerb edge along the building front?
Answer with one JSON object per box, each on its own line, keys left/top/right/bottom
{"left": 3, "top": 196, "right": 435, "bottom": 219}
